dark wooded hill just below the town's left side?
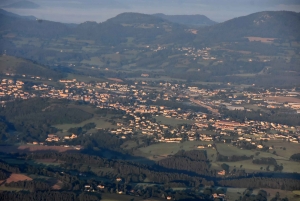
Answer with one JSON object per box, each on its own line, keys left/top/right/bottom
{"left": 0, "top": 98, "right": 93, "bottom": 142}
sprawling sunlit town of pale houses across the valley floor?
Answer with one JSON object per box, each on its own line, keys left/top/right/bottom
{"left": 0, "top": 75, "right": 300, "bottom": 149}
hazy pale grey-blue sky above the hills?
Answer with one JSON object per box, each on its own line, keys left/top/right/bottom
{"left": 0, "top": 0, "right": 300, "bottom": 23}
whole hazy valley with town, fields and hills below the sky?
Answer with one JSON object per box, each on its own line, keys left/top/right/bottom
{"left": 0, "top": 7, "right": 300, "bottom": 201}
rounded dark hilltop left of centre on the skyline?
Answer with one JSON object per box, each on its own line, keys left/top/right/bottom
{"left": 76, "top": 13, "right": 194, "bottom": 45}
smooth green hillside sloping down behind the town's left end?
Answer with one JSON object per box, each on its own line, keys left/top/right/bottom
{"left": 0, "top": 55, "right": 64, "bottom": 79}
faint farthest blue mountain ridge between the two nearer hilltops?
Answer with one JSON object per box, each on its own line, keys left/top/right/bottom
{"left": 153, "top": 13, "right": 217, "bottom": 27}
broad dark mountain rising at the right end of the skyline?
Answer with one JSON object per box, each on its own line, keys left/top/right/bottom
{"left": 198, "top": 11, "right": 300, "bottom": 41}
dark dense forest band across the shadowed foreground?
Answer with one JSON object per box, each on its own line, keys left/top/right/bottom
{"left": 0, "top": 151, "right": 299, "bottom": 200}
